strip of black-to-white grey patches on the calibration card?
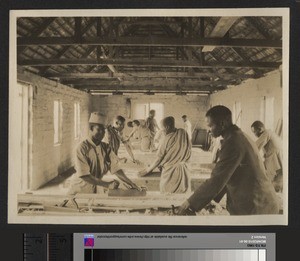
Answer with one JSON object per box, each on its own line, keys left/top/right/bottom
{"left": 85, "top": 249, "right": 266, "bottom": 261}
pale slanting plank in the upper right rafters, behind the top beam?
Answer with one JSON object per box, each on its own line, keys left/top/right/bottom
{"left": 202, "top": 16, "right": 239, "bottom": 52}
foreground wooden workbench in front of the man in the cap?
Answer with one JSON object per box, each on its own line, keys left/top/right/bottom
{"left": 18, "top": 191, "right": 226, "bottom": 215}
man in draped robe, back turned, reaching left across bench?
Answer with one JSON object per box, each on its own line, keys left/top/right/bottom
{"left": 139, "top": 117, "right": 192, "bottom": 193}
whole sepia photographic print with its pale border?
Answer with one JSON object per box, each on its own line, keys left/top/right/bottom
{"left": 8, "top": 8, "right": 290, "bottom": 223}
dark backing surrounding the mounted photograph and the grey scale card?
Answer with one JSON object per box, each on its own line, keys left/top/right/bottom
{"left": 0, "top": 0, "right": 300, "bottom": 261}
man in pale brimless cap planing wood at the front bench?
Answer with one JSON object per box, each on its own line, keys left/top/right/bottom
{"left": 68, "top": 112, "right": 141, "bottom": 194}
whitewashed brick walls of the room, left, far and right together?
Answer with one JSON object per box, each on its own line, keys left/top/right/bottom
{"left": 18, "top": 68, "right": 282, "bottom": 189}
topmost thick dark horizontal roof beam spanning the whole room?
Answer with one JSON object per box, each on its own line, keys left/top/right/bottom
{"left": 17, "top": 35, "right": 282, "bottom": 49}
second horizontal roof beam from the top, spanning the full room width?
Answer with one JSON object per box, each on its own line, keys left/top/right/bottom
{"left": 18, "top": 59, "right": 282, "bottom": 69}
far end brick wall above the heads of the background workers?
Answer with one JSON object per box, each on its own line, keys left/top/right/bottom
{"left": 92, "top": 95, "right": 209, "bottom": 133}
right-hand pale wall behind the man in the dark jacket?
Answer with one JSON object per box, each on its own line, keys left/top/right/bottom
{"left": 210, "top": 71, "right": 283, "bottom": 139}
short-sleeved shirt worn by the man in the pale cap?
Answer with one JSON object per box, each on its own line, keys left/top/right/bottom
{"left": 69, "top": 138, "right": 120, "bottom": 194}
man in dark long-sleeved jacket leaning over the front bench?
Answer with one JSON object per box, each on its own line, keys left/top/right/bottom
{"left": 177, "top": 106, "right": 279, "bottom": 215}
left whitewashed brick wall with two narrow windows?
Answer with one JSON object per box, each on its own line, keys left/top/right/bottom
{"left": 18, "top": 72, "right": 90, "bottom": 189}
